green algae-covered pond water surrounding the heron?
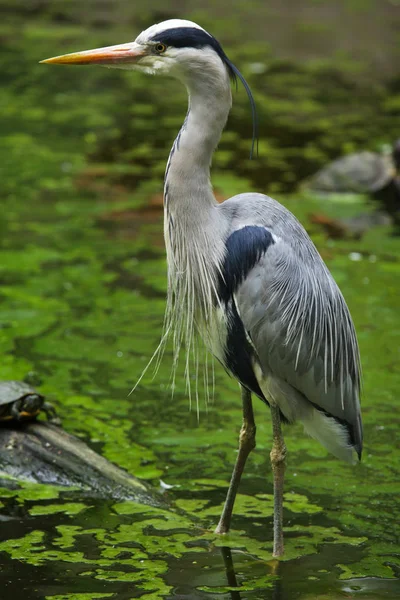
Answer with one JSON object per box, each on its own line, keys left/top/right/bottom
{"left": 0, "top": 0, "right": 400, "bottom": 600}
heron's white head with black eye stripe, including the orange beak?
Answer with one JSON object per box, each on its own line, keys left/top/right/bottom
{"left": 41, "top": 19, "right": 234, "bottom": 79}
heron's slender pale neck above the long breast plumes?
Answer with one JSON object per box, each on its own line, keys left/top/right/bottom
{"left": 164, "top": 65, "right": 232, "bottom": 219}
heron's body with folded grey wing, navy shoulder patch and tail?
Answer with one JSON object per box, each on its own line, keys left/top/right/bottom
{"left": 218, "top": 194, "right": 362, "bottom": 459}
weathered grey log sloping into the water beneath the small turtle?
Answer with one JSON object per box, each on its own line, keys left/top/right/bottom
{"left": 0, "top": 421, "right": 167, "bottom": 507}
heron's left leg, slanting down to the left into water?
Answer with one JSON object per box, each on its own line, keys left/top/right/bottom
{"left": 215, "top": 386, "right": 256, "bottom": 533}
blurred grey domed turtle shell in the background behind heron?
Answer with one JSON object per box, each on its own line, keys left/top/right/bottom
{"left": 306, "top": 151, "right": 395, "bottom": 194}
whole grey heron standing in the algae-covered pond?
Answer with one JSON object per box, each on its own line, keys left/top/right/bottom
{"left": 42, "top": 19, "right": 362, "bottom": 556}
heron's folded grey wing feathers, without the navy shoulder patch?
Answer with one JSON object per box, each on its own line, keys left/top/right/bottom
{"left": 235, "top": 238, "right": 362, "bottom": 458}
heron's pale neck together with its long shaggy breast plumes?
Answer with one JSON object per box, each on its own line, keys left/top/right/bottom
{"left": 164, "top": 55, "right": 232, "bottom": 356}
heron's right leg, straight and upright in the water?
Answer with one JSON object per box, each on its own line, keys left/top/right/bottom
{"left": 270, "top": 402, "right": 286, "bottom": 556}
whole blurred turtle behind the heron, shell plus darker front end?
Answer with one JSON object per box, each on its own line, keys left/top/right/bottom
{"left": 304, "top": 139, "right": 400, "bottom": 232}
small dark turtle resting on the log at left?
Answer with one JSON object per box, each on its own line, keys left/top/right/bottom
{"left": 0, "top": 381, "right": 61, "bottom": 425}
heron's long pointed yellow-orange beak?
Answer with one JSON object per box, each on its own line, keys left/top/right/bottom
{"left": 40, "top": 42, "right": 145, "bottom": 66}
